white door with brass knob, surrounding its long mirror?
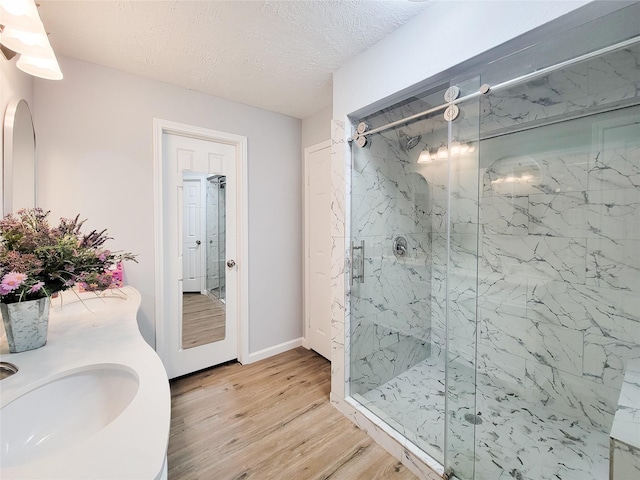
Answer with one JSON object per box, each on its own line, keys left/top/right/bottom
{"left": 162, "top": 133, "right": 240, "bottom": 378}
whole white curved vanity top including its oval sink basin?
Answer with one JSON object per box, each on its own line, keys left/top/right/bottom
{"left": 0, "top": 287, "right": 171, "bottom": 480}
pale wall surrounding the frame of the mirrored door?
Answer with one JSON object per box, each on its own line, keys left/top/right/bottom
{"left": 34, "top": 57, "right": 302, "bottom": 353}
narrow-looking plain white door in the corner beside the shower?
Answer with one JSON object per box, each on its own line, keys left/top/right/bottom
{"left": 305, "top": 142, "right": 331, "bottom": 360}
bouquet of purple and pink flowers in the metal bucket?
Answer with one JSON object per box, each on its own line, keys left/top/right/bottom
{"left": 0, "top": 208, "right": 136, "bottom": 303}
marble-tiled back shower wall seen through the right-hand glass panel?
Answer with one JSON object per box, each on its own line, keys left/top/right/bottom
{"left": 477, "top": 48, "right": 640, "bottom": 430}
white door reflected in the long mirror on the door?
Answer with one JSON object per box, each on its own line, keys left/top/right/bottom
{"left": 182, "top": 176, "right": 206, "bottom": 292}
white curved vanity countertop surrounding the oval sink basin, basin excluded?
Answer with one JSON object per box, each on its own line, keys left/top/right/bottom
{"left": 0, "top": 287, "right": 171, "bottom": 480}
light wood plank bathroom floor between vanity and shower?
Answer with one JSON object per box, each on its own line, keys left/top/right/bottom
{"left": 168, "top": 347, "right": 417, "bottom": 480}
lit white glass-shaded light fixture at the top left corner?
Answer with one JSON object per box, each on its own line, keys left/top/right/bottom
{"left": 0, "top": 0, "right": 62, "bottom": 80}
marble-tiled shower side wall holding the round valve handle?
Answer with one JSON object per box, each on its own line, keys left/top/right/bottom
{"left": 350, "top": 124, "right": 431, "bottom": 393}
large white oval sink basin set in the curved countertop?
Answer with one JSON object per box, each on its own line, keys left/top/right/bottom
{"left": 0, "top": 365, "right": 139, "bottom": 467}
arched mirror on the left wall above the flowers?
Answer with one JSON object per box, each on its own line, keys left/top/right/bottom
{"left": 3, "top": 99, "right": 36, "bottom": 215}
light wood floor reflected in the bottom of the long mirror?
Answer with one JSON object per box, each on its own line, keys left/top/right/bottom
{"left": 182, "top": 293, "right": 225, "bottom": 348}
